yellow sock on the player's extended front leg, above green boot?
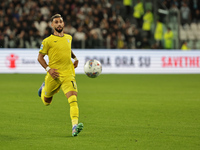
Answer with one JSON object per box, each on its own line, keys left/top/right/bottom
{"left": 68, "top": 95, "right": 79, "bottom": 126}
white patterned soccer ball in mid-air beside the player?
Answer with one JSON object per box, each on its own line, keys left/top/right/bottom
{"left": 84, "top": 59, "right": 102, "bottom": 78}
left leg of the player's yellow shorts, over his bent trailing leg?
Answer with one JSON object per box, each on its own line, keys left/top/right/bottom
{"left": 44, "top": 74, "right": 61, "bottom": 98}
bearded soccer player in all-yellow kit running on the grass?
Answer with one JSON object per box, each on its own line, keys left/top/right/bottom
{"left": 38, "top": 14, "right": 83, "bottom": 136}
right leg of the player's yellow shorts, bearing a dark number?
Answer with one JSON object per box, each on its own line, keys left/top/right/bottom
{"left": 61, "top": 79, "right": 78, "bottom": 94}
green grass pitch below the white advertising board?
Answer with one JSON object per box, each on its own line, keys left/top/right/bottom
{"left": 0, "top": 74, "right": 200, "bottom": 150}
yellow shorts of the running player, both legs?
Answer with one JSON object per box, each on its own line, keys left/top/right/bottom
{"left": 43, "top": 73, "right": 78, "bottom": 98}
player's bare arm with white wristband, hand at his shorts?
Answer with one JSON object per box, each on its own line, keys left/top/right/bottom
{"left": 38, "top": 53, "right": 59, "bottom": 79}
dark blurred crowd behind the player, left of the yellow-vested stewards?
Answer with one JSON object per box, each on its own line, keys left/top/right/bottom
{"left": 0, "top": 0, "right": 132, "bottom": 48}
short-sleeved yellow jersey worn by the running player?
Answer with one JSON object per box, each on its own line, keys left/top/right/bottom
{"left": 39, "top": 34, "right": 75, "bottom": 77}
